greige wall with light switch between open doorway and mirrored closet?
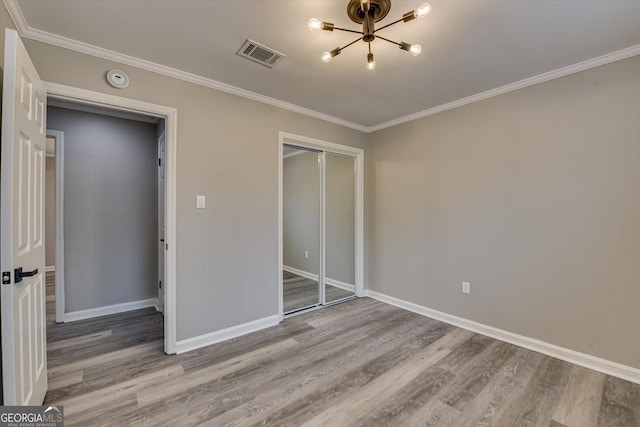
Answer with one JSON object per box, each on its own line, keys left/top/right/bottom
{"left": 25, "top": 40, "right": 367, "bottom": 340}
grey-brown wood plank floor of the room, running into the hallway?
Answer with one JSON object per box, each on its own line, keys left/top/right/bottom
{"left": 46, "top": 272, "right": 640, "bottom": 427}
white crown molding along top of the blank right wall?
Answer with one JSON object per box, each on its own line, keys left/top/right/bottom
{"left": 367, "top": 45, "right": 640, "bottom": 133}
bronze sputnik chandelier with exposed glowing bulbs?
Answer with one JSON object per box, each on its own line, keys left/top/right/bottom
{"left": 309, "top": 0, "right": 431, "bottom": 70}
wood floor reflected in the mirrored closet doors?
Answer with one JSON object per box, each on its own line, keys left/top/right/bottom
{"left": 282, "top": 271, "right": 354, "bottom": 313}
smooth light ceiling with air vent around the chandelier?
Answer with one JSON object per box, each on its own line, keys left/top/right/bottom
{"left": 11, "top": 0, "right": 640, "bottom": 127}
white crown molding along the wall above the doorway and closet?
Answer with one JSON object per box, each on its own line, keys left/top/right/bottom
{"left": 3, "top": 0, "right": 369, "bottom": 133}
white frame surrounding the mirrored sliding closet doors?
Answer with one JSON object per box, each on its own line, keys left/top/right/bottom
{"left": 277, "top": 131, "right": 365, "bottom": 321}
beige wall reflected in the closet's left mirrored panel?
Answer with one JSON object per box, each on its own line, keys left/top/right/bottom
{"left": 282, "top": 151, "right": 320, "bottom": 274}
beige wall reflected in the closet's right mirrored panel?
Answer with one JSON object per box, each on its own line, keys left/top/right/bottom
{"left": 325, "top": 153, "right": 356, "bottom": 285}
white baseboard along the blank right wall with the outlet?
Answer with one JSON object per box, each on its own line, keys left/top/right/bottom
{"left": 366, "top": 290, "right": 640, "bottom": 384}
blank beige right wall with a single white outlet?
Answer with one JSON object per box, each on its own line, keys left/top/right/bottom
{"left": 367, "top": 56, "right": 640, "bottom": 368}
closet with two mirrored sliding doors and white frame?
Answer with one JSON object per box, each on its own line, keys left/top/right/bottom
{"left": 278, "top": 132, "right": 364, "bottom": 318}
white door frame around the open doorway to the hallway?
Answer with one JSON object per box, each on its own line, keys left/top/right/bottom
{"left": 44, "top": 82, "right": 178, "bottom": 354}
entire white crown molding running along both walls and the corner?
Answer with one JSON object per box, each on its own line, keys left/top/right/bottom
{"left": 2, "top": 0, "right": 640, "bottom": 133}
